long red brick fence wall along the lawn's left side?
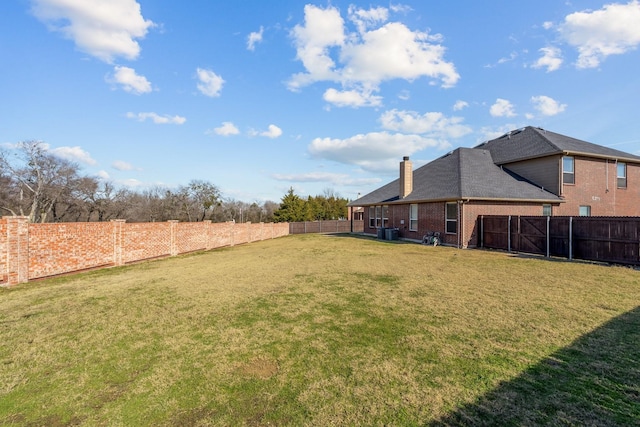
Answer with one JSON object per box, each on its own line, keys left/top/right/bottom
{"left": 0, "top": 217, "right": 289, "bottom": 286}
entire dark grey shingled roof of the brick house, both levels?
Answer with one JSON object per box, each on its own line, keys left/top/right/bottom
{"left": 349, "top": 126, "right": 640, "bottom": 206}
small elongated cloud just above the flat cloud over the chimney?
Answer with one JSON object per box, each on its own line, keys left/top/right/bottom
{"left": 380, "top": 109, "right": 471, "bottom": 140}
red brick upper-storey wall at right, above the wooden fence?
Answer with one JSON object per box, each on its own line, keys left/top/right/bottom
{"left": 553, "top": 157, "right": 640, "bottom": 216}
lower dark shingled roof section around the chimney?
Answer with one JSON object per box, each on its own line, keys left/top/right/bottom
{"left": 350, "top": 148, "right": 562, "bottom": 206}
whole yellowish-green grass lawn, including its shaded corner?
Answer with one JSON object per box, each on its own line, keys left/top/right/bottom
{"left": 0, "top": 235, "right": 640, "bottom": 426}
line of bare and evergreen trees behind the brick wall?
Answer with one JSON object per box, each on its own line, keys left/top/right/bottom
{"left": 0, "top": 141, "right": 348, "bottom": 223}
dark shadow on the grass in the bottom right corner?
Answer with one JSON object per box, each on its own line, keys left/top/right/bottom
{"left": 429, "top": 307, "right": 640, "bottom": 426}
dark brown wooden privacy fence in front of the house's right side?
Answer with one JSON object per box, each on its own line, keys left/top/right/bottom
{"left": 478, "top": 215, "right": 640, "bottom": 265}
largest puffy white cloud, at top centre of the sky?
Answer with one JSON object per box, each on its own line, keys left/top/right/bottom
{"left": 288, "top": 5, "right": 460, "bottom": 106}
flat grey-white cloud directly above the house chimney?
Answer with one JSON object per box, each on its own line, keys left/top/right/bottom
{"left": 308, "top": 132, "right": 451, "bottom": 171}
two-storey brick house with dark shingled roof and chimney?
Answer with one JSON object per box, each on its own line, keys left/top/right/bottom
{"left": 349, "top": 126, "right": 640, "bottom": 248}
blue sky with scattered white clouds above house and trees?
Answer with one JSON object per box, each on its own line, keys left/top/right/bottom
{"left": 0, "top": 0, "right": 640, "bottom": 202}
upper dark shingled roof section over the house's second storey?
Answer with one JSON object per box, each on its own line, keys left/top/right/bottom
{"left": 476, "top": 126, "right": 640, "bottom": 165}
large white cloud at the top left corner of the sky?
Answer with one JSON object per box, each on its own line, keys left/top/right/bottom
{"left": 32, "top": 0, "right": 154, "bottom": 63}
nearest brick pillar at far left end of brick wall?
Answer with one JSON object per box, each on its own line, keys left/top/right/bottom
{"left": 4, "top": 216, "right": 29, "bottom": 286}
